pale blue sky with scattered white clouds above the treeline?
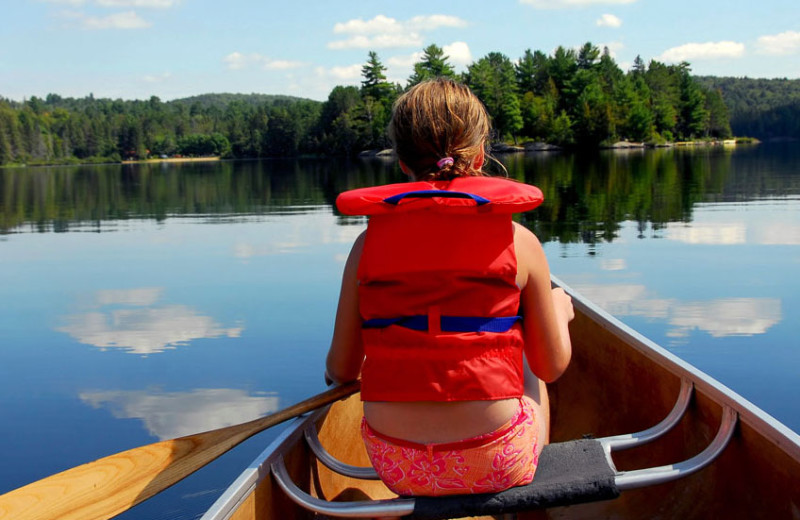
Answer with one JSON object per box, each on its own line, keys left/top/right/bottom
{"left": 0, "top": 0, "right": 800, "bottom": 100}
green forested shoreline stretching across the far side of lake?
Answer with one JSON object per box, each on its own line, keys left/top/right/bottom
{"left": 0, "top": 43, "right": 800, "bottom": 165}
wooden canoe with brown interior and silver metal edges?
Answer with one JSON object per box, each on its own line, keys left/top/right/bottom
{"left": 202, "top": 284, "right": 800, "bottom": 520}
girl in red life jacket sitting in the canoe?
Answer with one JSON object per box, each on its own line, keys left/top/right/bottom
{"left": 327, "top": 79, "right": 573, "bottom": 496}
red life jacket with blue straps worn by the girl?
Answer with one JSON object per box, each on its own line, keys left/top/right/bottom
{"left": 336, "top": 177, "right": 543, "bottom": 401}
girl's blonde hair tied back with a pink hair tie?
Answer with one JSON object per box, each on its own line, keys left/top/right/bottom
{"left": 388, "top": 78, "right": 491, "bottom": 180}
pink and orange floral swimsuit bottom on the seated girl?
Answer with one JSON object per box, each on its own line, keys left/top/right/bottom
{"left": 361, "top": 397, "right": 539, "bottom": 496}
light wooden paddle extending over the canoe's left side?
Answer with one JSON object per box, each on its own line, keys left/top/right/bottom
{"left": 0, "top": 381, "right": 360, "bottom": 520}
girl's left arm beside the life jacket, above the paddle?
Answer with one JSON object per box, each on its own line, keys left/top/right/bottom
{"left": 325, "top": 233, "right": 364, "bottom": 383}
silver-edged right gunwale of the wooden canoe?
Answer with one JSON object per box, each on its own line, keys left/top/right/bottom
{"left": 551, "top": 275, "right": 800, "bottom": 460}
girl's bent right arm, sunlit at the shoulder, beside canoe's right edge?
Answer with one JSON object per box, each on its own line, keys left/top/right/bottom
{"left": 514, "top": 224, "right": 575, "bottom": 383}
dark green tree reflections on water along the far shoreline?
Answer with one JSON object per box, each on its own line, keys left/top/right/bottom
{"left": 0, "top": 147, "right": 800, "bottom": 246}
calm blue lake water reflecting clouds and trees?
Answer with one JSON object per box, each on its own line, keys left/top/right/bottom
{"left": 0, "top": 145, "right": 800, "bottom": 519}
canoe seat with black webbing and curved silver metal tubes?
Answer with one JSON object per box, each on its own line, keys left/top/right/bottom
{"left": 271, "top": 381, "right": 737, "bottom": 519}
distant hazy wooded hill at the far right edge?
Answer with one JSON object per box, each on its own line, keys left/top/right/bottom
{"left": 695, "top": 76, "right": 800, "bottom": 140}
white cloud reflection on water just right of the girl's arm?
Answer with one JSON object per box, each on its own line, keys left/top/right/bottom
{"left": 574, "top": 284, "right": 783, "bottom": 339}
